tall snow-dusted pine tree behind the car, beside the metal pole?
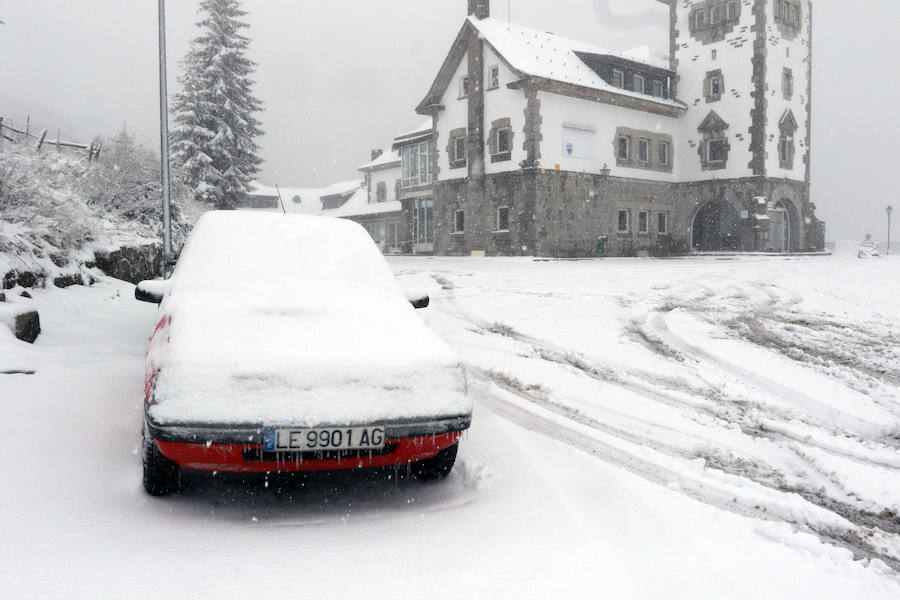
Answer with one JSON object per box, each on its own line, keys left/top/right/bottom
{"left": 172, "top": 0, "right": 262, "bottom": 209}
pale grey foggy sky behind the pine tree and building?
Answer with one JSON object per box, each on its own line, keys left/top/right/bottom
{"left": 0, "top": 0, "right": 900, "bottom": 240}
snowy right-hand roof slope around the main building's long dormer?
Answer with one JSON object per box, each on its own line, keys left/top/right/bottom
{"left": 469, "top": 17, "right": 681, "bottom": 106}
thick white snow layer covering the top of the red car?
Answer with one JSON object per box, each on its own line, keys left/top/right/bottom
{"left": 142, "top": 213, "right": 472, "bottom": 426}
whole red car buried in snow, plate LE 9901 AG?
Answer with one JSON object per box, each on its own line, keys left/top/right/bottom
{"left": 135, "top": 211, "right": 472, "bottom": 495}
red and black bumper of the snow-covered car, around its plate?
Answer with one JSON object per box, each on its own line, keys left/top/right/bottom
{"left": 145, "top": 416, "right": 472, "bottom": 473}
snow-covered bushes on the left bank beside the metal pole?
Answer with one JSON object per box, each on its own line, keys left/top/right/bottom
{"left": 0, "top": 132, "right": 188, "bottom": 284}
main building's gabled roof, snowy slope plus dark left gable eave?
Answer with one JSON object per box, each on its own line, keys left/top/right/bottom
{"left": 416, "top": 17, "right": 683, "bottom": 114}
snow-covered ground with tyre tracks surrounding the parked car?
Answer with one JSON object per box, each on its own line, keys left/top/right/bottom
{"left": 0, "top": 253, "right": 900, "bottom": 599}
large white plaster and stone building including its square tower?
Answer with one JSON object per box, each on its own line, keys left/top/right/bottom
{"left": 414, "top": 0, "right": 824, "bottom": 256}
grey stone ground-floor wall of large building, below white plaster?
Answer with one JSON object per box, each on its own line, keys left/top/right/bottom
{"left": 435, "top": 169, "right": 818, "bottom": 257}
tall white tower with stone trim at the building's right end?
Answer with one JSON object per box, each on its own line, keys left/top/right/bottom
{"left": 659, "top": 0, "right": 824, "bottom": 252}
